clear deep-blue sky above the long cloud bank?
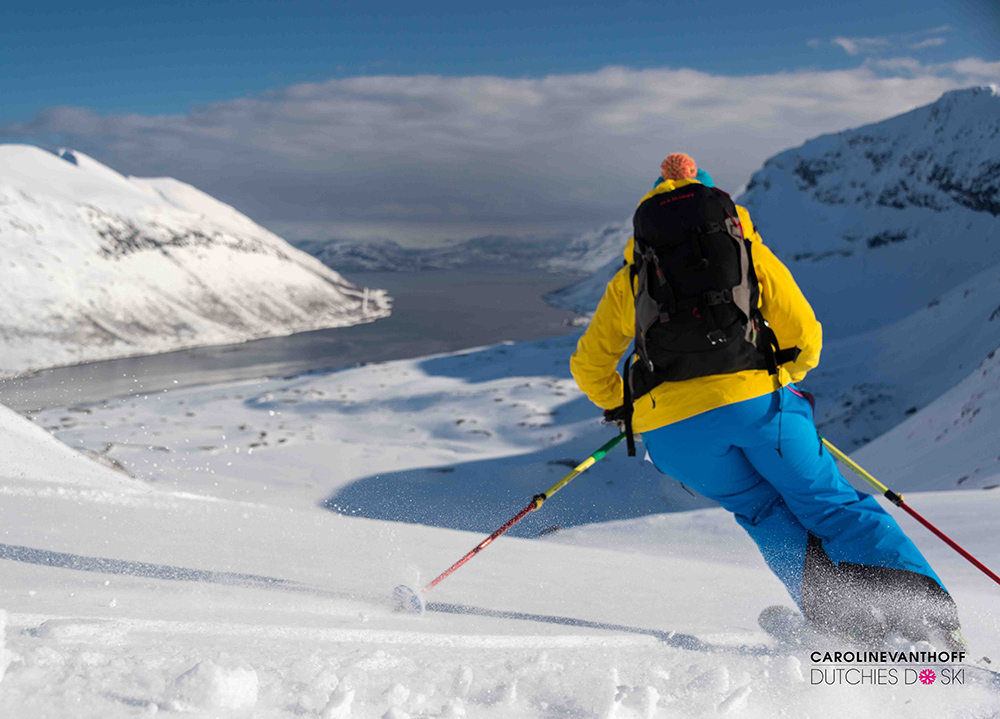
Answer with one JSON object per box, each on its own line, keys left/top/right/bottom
{"left": 0, "top": 0, "right": 1000, "bottom": 120}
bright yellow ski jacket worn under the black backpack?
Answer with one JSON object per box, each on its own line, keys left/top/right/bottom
{"left": 570, "top": 180, "right": 823, "bottom": 433}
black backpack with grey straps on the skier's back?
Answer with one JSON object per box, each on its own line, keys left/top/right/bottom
{"left": 624, "top": 183, "right": 799, "bottom": 456}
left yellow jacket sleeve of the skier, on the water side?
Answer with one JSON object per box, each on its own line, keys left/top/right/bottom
{"left": 569, "top": 267, "right": 633, "bottom": 409}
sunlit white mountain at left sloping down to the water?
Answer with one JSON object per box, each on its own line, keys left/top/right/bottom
{"left": 0, "top": 145, "right": 390, "bottom": 375}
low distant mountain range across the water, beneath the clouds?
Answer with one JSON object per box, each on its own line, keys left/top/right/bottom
{"left": 295, "top": 236, "right": 593, "bottom": 274}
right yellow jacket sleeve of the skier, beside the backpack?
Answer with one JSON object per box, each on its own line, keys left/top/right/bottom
{"left": 741, "top": 219, "right": 823, "bottom": 382}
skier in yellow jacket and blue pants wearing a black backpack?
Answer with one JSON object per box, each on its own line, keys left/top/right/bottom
{"left": 570, "top": 153, "right": 964, "bottom": 649}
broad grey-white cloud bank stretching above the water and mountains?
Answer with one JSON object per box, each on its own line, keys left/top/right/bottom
{"left": 0, "top": 58, "right": 1000, "bottom": 243}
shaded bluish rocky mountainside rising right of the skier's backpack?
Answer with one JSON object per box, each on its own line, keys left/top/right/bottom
{"left": 739, "top": 87, "right": 1000, "bottom": 337}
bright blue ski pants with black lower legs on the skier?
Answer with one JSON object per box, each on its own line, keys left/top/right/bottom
{"left": 642, "top": 387, "right": 957, "bottom": 624}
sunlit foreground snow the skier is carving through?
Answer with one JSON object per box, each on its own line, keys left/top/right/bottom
{"left": 0, "top": 423, "right": 998, "bottom": 719}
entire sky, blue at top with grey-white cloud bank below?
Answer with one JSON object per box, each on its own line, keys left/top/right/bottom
{"left": 0, "top": 0, "right": 1000, "bottom": 242}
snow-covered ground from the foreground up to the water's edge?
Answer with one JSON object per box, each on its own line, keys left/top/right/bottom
{"left": 7, "top": 338, "right": 1000, "bottom": 719}
